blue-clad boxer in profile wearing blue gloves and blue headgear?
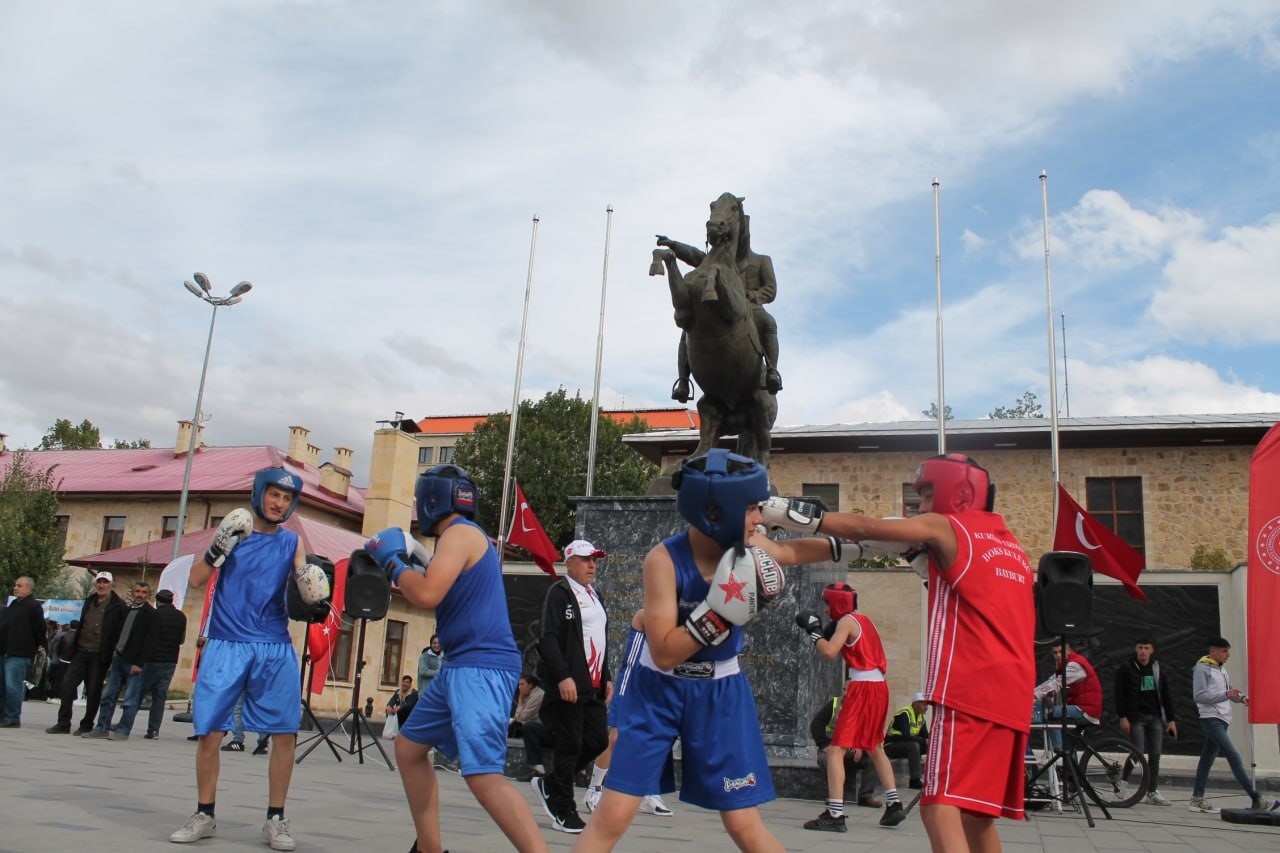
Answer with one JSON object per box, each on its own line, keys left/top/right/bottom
{"left": 365, "top": 465, "right": 547, "bottom": 853}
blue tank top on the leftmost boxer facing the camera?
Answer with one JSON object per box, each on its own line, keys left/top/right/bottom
{"left": 209, "top": 529, "right": 298, "bottom": 643}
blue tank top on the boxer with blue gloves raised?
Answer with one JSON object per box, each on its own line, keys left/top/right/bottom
{"left": 437, "top": 519, "right": 520, "bottom": 672}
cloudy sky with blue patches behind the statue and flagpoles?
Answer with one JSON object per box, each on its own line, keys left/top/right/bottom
{"left": 0, "top": 0, "right": 1280, "bottom": 480}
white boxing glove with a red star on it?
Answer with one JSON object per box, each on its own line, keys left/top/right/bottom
{"left": 685, "top": 548, "right": 786, "bottom": 646}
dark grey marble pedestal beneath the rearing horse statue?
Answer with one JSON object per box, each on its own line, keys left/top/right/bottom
{"left": 575, "top": 496, "right": 847, "bottom": 798}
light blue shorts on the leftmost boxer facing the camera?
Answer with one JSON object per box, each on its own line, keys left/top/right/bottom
{"left": 191, "top": 639, "right": 302, "bottom": 735}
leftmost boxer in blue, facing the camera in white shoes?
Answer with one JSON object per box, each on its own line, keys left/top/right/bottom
{"left": 169, "top": 467, "right": 306, "bottom": 850}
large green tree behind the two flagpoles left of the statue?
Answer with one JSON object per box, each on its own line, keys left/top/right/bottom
{"left": 453, "top": 388, "right": 658, "bottom": 547}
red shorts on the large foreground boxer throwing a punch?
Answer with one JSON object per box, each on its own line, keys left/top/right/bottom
{"left": 920, "top": 706, "right": 1027, "bottom": 821}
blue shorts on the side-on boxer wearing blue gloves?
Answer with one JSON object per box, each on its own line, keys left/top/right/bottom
{"left": 401, "top": 665, "right": 520, "bottom": 776}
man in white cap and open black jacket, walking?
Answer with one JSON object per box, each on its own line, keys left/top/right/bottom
{"left": 531, "top": 539, "right": 613, "bottom": 835}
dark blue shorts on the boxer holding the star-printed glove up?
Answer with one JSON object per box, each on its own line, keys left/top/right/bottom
{"left": 604, "top": 658, "right": 776, "bottom": 811}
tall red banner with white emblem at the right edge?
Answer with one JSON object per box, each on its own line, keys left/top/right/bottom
{"left": 1245, "top": 424, "right": 1280, "bottom": 722}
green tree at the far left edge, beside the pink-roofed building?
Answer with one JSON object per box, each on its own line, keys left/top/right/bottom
{"left": 0, "top": 451, "right": 65, "bottom": 598}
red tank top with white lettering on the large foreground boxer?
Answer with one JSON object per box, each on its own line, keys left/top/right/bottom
{"left": 924, "top": 511, "right": 1036, "bottom": 731}
